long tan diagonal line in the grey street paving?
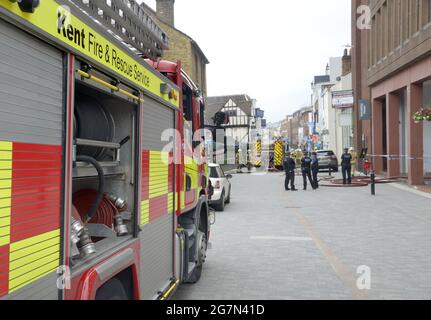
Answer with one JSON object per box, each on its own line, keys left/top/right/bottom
{"left": 292, "top": 209, "right": 368, "bottom": 299}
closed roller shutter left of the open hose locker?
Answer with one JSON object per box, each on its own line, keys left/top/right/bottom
{"left": 0, "top": 19, "right": 64, "bottom": 300}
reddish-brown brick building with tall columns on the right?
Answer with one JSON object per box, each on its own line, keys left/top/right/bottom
{"left": 352, "top": 0, "right": 431, "bottom": 185}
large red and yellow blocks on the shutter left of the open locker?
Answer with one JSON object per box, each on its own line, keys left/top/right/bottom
{"left": 0, "top": 141, "right": 62, "bottom": 297}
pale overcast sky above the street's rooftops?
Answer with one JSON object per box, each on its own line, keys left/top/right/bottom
{"left": 138, "top": 0, "right": 351, "bottom": 122}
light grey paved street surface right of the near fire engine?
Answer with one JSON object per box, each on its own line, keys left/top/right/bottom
{"left": 174, "top": 173, "right": 431, "bottom": 300}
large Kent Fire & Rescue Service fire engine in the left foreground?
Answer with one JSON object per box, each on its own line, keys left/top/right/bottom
{"left": 0, "top": 0, "right": 210, "bottom": 300}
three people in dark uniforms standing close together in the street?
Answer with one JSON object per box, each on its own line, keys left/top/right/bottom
{"left": 284, "top": 152, "right": 319, "bottom": 191}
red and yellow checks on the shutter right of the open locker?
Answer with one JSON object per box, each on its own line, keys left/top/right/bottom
{"left": 141, "top": 150, "right": 174, "bottom": 225}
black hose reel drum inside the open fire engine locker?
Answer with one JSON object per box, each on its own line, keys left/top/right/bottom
{"left": 73, "top": 94, "right": 115, "bottom": 161}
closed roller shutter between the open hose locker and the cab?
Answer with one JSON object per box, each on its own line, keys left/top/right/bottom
{"left": 140, "top": 97, "right": 175, "bottom": 299}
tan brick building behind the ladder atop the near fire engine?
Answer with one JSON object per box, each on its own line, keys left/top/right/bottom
{"left": 141, "top": 0, "right": 209, "bottom": 97}
